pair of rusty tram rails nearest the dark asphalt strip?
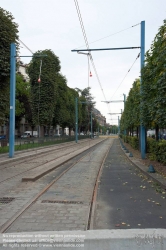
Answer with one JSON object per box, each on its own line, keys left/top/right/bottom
{"left": 0, "top": 139, "right": 112, "bottom": 233}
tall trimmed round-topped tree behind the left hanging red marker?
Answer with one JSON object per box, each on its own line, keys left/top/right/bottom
{"left": 28, "top": 50, "right": 60, "bottom": 126}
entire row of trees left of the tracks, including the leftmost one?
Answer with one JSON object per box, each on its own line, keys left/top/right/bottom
{"left": 0, "top": 8, "right": 105, "bottom": 136}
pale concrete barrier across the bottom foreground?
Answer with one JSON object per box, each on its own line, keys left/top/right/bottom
{"left": 0, "top": 229, "right": 166, "bottom": 250}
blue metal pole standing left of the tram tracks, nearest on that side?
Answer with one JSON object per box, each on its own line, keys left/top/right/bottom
{"left": 9, "top": 43, "right": 16, "bottom": 158}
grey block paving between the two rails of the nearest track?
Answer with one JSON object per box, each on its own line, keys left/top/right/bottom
{"left": 8, "top": 139, "right": 113, "bottom": 232}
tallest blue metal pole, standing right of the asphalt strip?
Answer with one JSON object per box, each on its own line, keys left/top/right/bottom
{"left": 140, "top": 21, "right": 146, "bottom": 159}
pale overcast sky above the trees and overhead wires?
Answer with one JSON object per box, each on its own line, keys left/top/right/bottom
{"left": 0, "top": 0, "right": 166, "bottom": 124}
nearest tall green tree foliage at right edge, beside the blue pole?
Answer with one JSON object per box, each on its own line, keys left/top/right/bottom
{"left": 142, "top": 20, "right": 166, "bottom": 128}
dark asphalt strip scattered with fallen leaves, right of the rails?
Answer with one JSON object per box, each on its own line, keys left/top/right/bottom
{"left": 94, "top": 139, "right": 166, "bottom": 229}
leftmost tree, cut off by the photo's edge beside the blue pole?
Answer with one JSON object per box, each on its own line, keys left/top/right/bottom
{"left": 0, "top": 7, "right": 18, "bottom": 124}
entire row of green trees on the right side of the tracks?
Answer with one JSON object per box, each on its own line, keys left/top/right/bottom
{"left": 121, "top": 20, "right": 166, "bottom": 141}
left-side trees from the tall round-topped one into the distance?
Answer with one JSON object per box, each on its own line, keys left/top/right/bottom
{"left": 28, "top": 50, "right": 98, "bottom": 135}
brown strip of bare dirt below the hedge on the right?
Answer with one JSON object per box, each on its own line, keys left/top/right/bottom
{"left": 123, "top": 142, "right": 166, "bottom": 177}
